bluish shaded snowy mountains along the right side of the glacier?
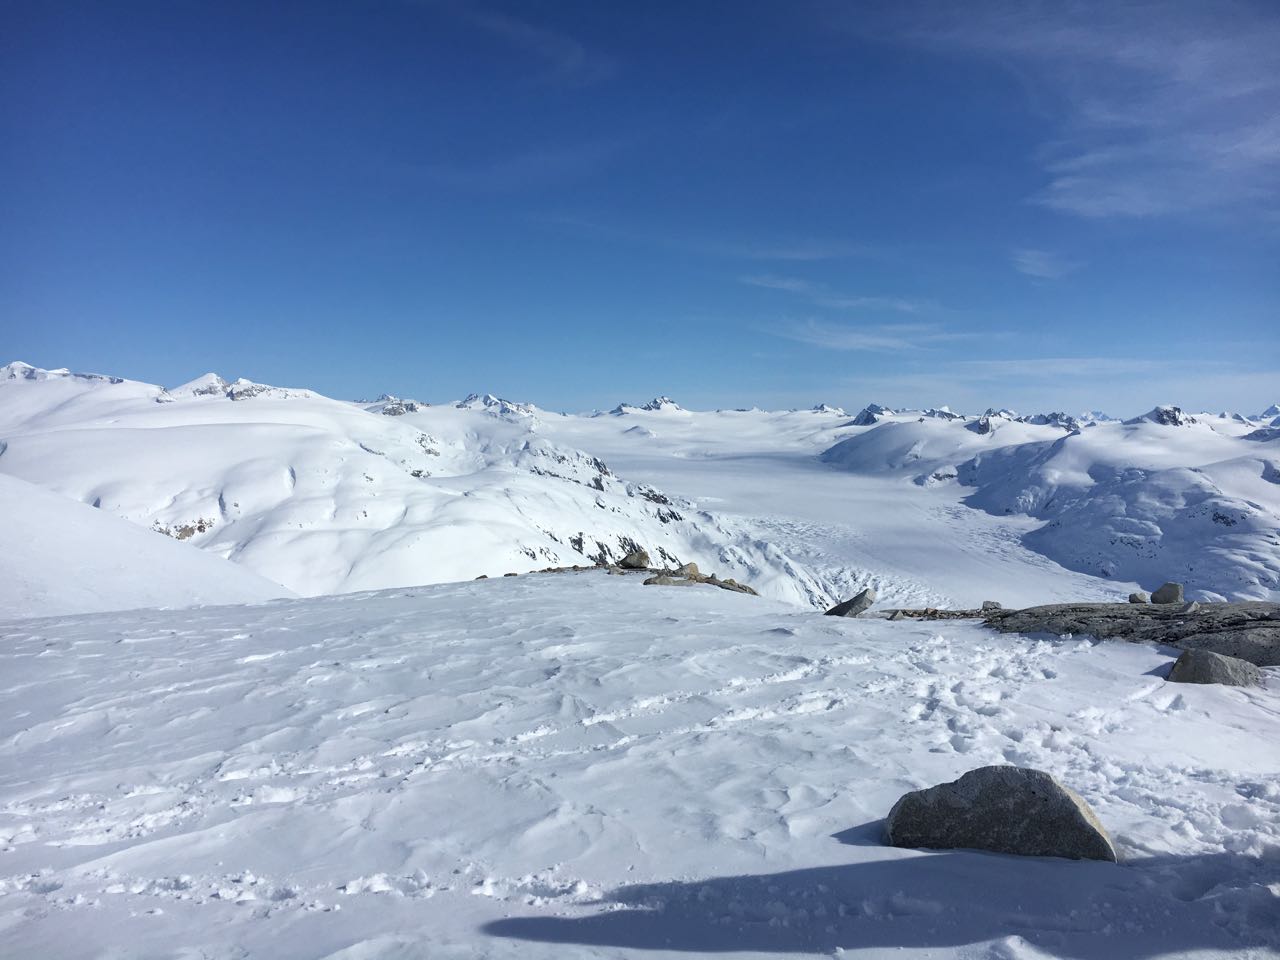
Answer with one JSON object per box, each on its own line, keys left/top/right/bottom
{"left": 822, "top": 406, "right": 1280, "bottom": 599}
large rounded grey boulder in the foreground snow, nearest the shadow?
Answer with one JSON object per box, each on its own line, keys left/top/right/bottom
{"left": 884, "top": 767, "right": 1116, "bottom": 863}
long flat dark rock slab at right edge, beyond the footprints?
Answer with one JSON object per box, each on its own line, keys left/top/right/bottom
{"left": 986, "top": 600, "right": 1280, "bottom": 667}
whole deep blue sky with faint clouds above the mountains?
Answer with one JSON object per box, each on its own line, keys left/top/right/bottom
{"left": 0, "top": 0, "right": 1280, "bottom": 412}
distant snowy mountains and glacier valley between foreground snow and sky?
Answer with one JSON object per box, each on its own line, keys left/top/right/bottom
{"left": 0, "top": 365, "right": 1280, "bottom": 605}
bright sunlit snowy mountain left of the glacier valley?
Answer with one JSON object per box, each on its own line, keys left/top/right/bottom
{"left": 0, "top": 367, "right": 829, "bottom": 605}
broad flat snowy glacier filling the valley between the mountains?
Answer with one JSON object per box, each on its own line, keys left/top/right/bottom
{"left": 541, "top": 407, "right": 1141, "bottom": 607}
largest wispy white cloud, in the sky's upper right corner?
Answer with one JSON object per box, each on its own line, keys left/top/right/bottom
{"left": 859, "top": 0, "right": 1280, "bottom": 219}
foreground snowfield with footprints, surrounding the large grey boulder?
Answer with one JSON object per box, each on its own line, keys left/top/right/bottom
{"left": 0, "top": 572, "right": 1280, "bottom": 960}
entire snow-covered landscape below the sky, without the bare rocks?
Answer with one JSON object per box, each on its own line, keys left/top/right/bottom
{"left": 0, "top": 364, "right": 1280, "bottom": 960}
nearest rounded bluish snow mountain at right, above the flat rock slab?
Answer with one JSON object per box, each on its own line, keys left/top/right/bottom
{"left": 959, "top": 419, "right": 1280, "bottom": 599}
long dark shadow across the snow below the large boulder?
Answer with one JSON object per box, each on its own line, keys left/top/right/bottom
{"left": 484, "top": 822, "right": 1280, "bottom": 960}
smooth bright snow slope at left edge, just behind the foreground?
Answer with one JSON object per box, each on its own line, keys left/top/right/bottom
{"left": 0, "top": 474, "right": 293, "bottom": 620}
